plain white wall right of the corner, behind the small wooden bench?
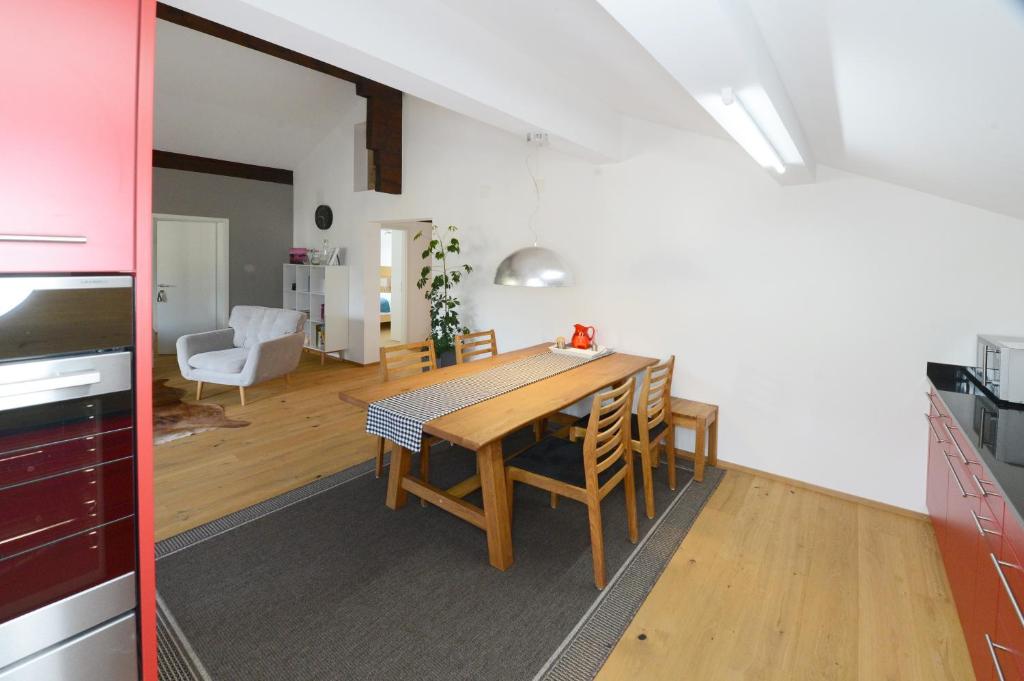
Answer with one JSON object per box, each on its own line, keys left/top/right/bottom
{"left": 593, "top": 116, "right": 1024, "bottom": 511}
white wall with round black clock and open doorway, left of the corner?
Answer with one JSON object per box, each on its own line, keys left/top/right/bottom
{"left": 294, "top": 95, "right": 599, "bottom": 363}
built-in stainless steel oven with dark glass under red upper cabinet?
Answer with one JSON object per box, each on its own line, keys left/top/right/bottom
{"left": 0, "top": 275, "right": 138, "bottom": 681}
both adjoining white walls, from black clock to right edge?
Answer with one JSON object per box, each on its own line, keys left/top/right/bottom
{"left": 295, "top": 97, "right": 1024, "bottom": 510}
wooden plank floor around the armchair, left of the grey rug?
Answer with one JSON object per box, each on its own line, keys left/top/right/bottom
{"left": 154, "top": 353, "right": 380, "bottom": 542}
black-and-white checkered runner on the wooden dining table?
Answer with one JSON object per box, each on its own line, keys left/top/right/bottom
{"left": 367, "top": 352, "right": 605, "bottom": 452}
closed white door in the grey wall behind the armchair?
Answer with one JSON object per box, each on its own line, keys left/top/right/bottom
{"left": 153, "top": 216, "right": 227, "bottom": 354}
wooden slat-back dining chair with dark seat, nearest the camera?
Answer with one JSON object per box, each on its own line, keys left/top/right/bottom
{"left": 506, "top": 378, "right": 638, "bottom": 589}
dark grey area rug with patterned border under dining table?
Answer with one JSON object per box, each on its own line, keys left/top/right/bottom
{"left": 157, "top": 434, "right": 724, "bottom": 681}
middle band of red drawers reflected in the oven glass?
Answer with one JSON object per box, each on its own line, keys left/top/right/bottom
{"left": 0, "top": 459, "right": 135, "bottom": 560}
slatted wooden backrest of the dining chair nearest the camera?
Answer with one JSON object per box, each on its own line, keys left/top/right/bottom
{"left": 583, "top": 378, "right": 635, "bottom": 486}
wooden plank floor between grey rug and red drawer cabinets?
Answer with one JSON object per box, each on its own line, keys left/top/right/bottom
{"left": 598, "top": 470, "right": 974, "bottom": 681}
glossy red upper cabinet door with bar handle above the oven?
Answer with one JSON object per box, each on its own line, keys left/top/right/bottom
{"left": 0, "top": 0, "right": 141, "bottom": 272}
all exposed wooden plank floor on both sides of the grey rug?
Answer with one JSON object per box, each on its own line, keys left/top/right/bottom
{"left": 149, "top": 355, "right": 974, "bottom": 681}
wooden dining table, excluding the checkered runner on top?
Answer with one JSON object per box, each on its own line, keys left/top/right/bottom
{"left": 339, "top": 343, "right": 657, "bottom": 570}
